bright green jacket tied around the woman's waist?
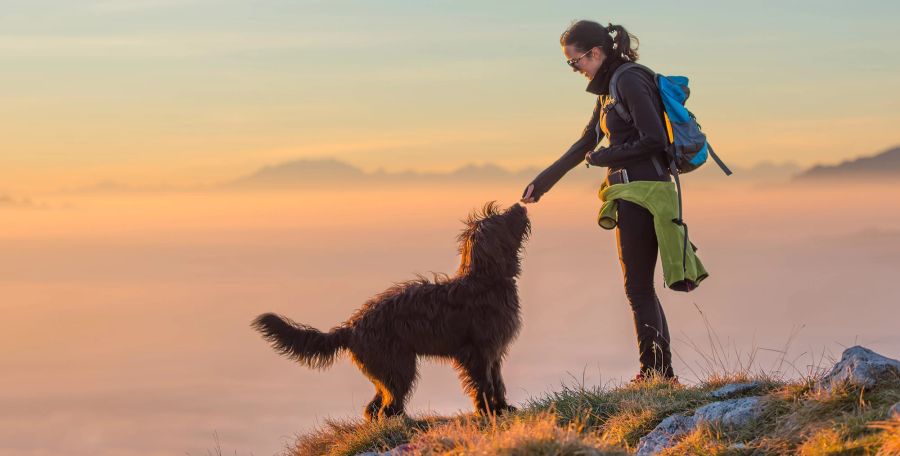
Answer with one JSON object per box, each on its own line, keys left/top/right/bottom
{"left": 597, "top": 181, "right": 709, "bottom": 291}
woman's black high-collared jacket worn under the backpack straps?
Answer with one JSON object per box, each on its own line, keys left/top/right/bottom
{"left": 523, "top": 58, "right": 671, "bottom": 201}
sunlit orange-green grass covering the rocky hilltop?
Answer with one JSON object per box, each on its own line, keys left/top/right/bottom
{"left": 285, "top": 307, "right": 900, "bottom": 456}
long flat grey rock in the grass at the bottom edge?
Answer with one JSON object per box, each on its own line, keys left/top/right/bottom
{"left": 635, "top": 396, "right": 763, "bottom": 456}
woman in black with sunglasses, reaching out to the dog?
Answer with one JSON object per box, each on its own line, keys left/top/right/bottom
{"left": 522, "top": 21, "right": 677, "bottom": 382}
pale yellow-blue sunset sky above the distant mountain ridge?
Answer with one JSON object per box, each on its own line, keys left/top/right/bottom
{"left": 0, "top": 0, "right": 900, "bottom": 195}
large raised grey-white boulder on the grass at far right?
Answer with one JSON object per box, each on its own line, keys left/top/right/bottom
{"left": 818, "top": 345, "right": 900, "bottom": 391}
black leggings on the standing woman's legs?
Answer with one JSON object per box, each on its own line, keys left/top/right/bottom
{"left": 616, "top": 199, "right": 674, "bottom": 377}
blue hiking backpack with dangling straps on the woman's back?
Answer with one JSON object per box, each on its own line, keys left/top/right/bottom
{"left": 609, "top": 62, "right": 731, "bottom": 284}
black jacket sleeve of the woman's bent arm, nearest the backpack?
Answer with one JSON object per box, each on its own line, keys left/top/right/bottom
{"left": 591, "top": 71, "right": 668, "bottom": 166}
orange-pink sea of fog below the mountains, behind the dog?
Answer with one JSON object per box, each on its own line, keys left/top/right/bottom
{"left": 0, "top": 178, "right": 900, "bottom": 456}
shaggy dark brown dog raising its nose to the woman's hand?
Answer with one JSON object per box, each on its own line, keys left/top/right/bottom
{"left": 252, "top": 202, "right": 531, "bottom": 420}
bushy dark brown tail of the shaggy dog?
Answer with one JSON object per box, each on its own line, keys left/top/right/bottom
{"left": 250, "top": 313, "right": 349, "bottom": 369}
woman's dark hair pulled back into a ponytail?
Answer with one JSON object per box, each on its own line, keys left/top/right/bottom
{"left": 559, "top": 20, "right": 640, "bottom": 62}
